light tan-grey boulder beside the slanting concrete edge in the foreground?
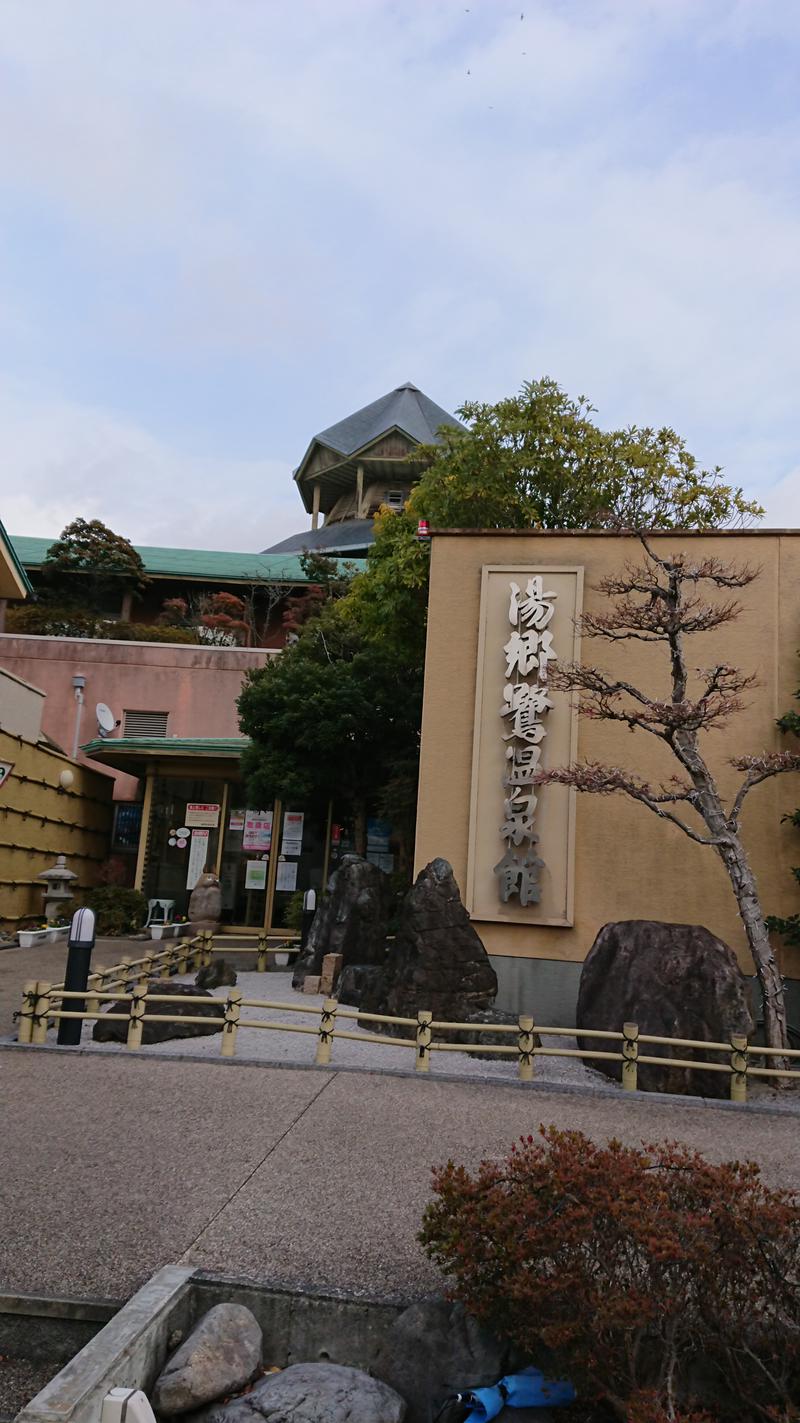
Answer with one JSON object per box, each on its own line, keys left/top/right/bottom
{"left": 152, "top": 1305, "right": 262, "bottom": 1417}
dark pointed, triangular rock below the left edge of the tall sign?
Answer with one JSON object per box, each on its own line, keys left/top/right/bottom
{"left": 359, "top": 859, "right": 497, "bottom": 1033}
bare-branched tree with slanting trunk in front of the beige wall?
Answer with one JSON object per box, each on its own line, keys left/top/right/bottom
{"left": 537, "top": 535, "right": 800, "bottom": 1047}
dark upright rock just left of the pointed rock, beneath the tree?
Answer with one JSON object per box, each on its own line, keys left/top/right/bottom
{"left": 292, "top": 855, "right": 391, "bottom": 988}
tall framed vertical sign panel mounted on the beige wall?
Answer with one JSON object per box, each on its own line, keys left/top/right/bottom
{"left": 465, "top": 564, "right": 584, "bottom": 925}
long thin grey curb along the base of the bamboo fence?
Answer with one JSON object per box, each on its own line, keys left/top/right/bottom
{"left": 0, "top": 1037, "right": 800, "bottom": 1117}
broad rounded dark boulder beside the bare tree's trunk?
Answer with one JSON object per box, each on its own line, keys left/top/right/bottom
{"left": 575, "top": 919, "right": 753, "bottom": 1097}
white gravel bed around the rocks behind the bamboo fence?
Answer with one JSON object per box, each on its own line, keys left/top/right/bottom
{"left": 81, "top": 973, "right": 614, "bottom": 1087}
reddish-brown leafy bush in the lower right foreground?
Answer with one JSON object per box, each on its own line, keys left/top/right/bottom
{"left": 420, "top": 1127, "right": 800, "bottom": 1423}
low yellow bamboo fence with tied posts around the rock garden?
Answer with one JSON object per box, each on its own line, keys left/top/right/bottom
{"left": 16, "top": 933, "right": 800, "bottom": 1103}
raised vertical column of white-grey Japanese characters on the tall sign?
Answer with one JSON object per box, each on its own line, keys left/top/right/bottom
{"left": 494, "top": 573, "right": 557, "bottom": 906}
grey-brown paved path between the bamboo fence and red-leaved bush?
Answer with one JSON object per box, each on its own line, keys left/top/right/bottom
{"left": 0, "top": 1047, "right": 800, "bottom": 1299}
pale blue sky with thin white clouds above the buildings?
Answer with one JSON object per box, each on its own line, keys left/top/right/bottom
{"left": 0, "top": 0, "right": 800, "bottom": 551}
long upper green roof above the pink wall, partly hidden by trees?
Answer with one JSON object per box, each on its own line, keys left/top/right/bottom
{"left": 9, "top": 529, "right": 366, "bottom": 583}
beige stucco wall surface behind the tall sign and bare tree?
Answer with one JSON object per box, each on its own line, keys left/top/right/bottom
{"left": 416, "top": 531, "right": 800, "bottom": 976}
